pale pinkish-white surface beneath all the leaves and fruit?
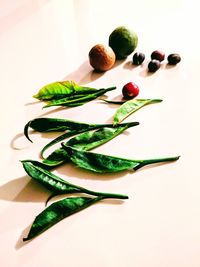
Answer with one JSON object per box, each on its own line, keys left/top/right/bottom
{"left": 0, "top": 0, "right": 200, "bottom": 267}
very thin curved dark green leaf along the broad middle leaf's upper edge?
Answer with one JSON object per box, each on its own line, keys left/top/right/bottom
{"left": 41, "top": 122, "right": 139, "bottom": 158}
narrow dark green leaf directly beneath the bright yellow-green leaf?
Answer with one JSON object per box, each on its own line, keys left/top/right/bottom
{"left": 43, "top": 87, "right": 116, "bottom": 108}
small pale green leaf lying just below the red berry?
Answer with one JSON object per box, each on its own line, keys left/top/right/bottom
{"left": 113, "top": 99, "right": 162, "bottom": 125}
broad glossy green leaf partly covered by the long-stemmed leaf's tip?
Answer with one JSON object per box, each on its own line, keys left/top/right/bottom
{"left": 43, "top": 122, "right": 139, "bottom": 167}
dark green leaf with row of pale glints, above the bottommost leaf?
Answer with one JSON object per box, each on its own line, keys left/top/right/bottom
{"left": 21, "top": 160, "right": 128, "bottom": 199}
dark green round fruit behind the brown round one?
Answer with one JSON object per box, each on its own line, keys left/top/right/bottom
{"left": 109, "top": 26, "right": 138, "bottom": 59}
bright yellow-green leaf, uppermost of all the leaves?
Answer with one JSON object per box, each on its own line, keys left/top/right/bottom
{"left": 33, "top": 81, "right": 96, "bottom": 100}
